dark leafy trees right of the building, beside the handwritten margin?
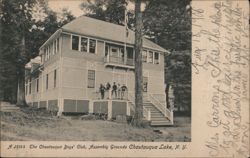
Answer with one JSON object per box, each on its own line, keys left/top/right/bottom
{"left": 144, "top": 0, "right": 191, "bottom": 113}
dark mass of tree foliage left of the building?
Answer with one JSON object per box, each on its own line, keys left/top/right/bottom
{"left": 0, "top": 0, "right": 74, "bottom": 102}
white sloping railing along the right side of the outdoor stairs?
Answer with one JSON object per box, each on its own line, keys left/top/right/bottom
{"left": 148, "top": 94, "right": 174, "bottom": 124}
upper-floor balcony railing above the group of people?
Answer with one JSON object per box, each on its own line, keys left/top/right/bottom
{"left": 104, "top": 56, "right": 134, "bottom": 67}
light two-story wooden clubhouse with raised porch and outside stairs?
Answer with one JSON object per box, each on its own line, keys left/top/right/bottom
{"left": 26, "top": 16, "right": 173, "bottom": 125}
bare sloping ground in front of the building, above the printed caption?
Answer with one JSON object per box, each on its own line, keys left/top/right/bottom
{"left": 0, "top": 102, "right": 191, "bottom": 142}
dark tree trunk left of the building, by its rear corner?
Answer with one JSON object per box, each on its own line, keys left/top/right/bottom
{"left": 16, "top": 35, "right": 26, "bottom": 106}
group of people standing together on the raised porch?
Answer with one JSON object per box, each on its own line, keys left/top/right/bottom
{"left": 99, "top": 82, "right": 128, "bottom": 99}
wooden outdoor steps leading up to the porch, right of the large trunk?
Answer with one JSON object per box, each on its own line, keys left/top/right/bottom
{"left": 143, "top": 101, "right": 172, "bottom": 126}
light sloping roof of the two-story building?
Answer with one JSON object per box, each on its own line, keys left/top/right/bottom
{"left": 61, "top": 16, "right": 168, "bottom": 52}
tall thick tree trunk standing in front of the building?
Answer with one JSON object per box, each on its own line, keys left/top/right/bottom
{"left": 132, "top": 0, "right": 143, "bottom": 127}
